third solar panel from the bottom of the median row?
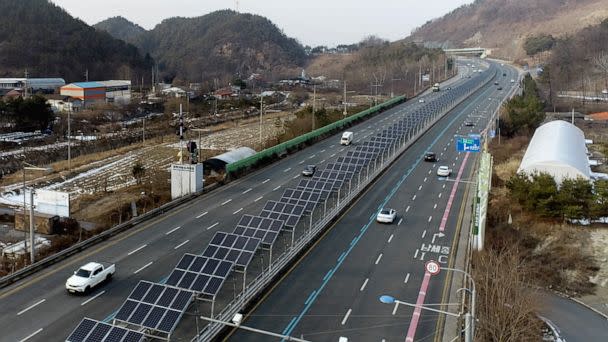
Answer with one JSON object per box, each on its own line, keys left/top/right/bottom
{"left": 161, "top": 255, "right": 234, "bottom": 299}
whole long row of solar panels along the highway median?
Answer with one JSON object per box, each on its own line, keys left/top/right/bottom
{"left": 67, "top": 62, "right": 495, "bottom": 342}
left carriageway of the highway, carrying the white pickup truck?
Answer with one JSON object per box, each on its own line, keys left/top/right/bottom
{"left": 0, "top": 62, "right": 472, "bottom": 341}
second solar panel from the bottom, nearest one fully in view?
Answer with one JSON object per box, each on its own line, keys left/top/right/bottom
{"left": 114, "top": 280, "right": 193, "bottom": 333}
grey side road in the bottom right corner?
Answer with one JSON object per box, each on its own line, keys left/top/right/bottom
{"left": 535, "top": 290, "right": 608, "bottom": 342}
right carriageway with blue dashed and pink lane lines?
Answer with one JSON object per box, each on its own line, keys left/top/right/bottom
{"left": 228, "top": 62, "right": 517, "bottom": 342}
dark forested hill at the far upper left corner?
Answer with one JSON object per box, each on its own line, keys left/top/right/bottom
{"left": 0, "top": 0, "right": 153, "bottom": 82}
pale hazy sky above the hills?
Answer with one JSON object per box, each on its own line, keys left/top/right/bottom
{"left": 52, "top": 0, "right": 473, "bottom": 46}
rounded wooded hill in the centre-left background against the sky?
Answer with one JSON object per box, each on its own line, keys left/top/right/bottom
{"left": 134, "top": 10, "right": 306, "bottom": 81}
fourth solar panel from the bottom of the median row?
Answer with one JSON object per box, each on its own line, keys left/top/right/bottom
{"left": 203, "top": 232, "right": 261, "bottom": 267}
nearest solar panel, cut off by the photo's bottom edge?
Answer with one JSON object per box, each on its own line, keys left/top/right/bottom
{"left": 66, "top": 318, "right": 144, "bottom": 342}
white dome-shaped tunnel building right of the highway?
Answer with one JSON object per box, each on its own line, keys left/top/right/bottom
{"left": 517, "top": 120, "right": 591, "bottom": 184}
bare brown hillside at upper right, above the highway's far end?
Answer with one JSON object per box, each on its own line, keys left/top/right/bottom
{"left": 409, "top": 0, "right": 608, "bottom": 59}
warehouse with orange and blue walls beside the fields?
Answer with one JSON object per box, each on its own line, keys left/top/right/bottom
{"left": 61, "top": 80, "right": 131, "bottom": 107}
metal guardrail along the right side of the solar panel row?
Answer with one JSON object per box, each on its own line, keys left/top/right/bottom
{"left": 191, "top": 72, "right": 496, "bottom": 341}
